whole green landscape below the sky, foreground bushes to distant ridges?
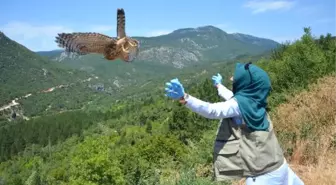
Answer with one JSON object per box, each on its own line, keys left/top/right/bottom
{"left": 0, "top": 23, "right": 336, "bottom": 185}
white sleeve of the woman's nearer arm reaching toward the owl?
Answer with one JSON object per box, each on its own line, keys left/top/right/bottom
{"left": 180, "top": 94, "right": 240, "bottom": 119}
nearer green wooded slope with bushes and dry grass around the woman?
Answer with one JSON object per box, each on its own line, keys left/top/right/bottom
{"left": 0, "top": 28, "right": 336, "bottom": 185}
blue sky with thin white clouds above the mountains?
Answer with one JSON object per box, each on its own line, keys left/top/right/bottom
{"left": 0, "top": 0, "right": 336, "bottom": 51}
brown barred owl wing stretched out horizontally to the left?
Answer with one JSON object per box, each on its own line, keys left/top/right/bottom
{"left": 55, "top": 32, "right": 116, "bottom": 55}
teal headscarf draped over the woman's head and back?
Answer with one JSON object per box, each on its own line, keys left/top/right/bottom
{"left": 233, "top": 63, "right": 271, "bottom": 131}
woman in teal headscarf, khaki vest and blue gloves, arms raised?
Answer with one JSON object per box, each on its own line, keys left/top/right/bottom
{"left": 165, "top": 63, "right": 304, "bottom": 185}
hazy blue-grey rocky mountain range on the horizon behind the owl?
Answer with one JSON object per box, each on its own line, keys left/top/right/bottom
{"left": 37, "top": 26, "right": 279, "bottom": 94}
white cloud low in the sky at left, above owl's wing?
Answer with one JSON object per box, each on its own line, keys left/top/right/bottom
{"left": 0, "top": 21, "right": 114, "bottom": 51}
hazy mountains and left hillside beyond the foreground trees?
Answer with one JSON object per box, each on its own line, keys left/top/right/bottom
{"left": 0, "top": 26, "right": 277, "bottom": 120}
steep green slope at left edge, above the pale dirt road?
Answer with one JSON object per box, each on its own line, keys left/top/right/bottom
{"left": 0, "top": 32, "right": 89, "bottom": 103}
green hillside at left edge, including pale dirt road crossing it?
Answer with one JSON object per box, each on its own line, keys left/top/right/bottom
{"left": 0, "top": 32, "right": 116, "bottom": 118}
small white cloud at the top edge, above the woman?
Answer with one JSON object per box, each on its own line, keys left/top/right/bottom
{"left": 244, "top": 0, "right": 295, "bottom": 14}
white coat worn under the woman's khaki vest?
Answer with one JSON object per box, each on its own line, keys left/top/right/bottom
{"left": 185, "top": 85, "right": 304, "bottom": 185}
